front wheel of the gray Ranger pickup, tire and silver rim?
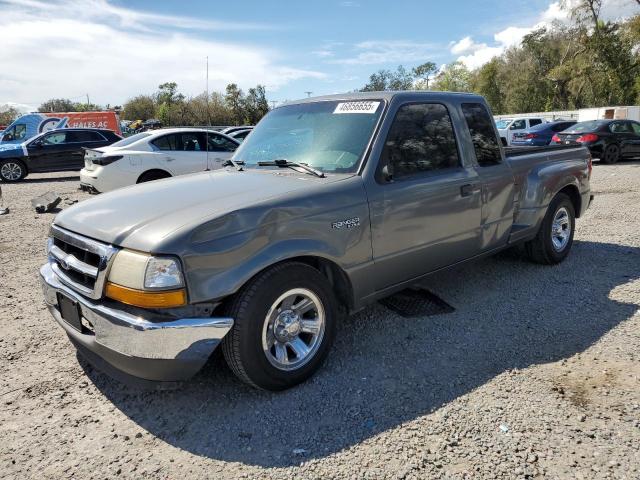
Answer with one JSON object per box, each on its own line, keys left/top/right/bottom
{"left": 222, "top": 262, "right": 339, "bottom": 390}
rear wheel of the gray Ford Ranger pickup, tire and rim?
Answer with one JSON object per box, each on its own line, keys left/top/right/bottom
{"left": 525, "top": 193, "right": 576, "bottom": 265}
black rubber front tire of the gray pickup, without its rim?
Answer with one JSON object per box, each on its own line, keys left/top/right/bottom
{"left": 222, "top": 262, "right": 339, "bottom": 391}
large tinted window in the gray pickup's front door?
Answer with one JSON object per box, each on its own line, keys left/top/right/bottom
{"left": 382, "top": 103, "right": 460, "bottom": 178}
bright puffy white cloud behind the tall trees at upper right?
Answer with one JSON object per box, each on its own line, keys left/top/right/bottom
{"left": 450, "top": 0, "right": 638, "bottom": 69}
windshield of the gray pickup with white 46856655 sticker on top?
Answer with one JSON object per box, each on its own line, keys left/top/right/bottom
{"left": 233, "top": 100, "right": 383, "bottom": 173}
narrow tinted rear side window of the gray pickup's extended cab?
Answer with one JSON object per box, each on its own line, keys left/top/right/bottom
{"left": 462, "top": 103, "right": 502, "bottom": 167}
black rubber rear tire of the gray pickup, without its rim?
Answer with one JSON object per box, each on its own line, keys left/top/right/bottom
{"left": 524, "top": 193, "right": 576, "bottom": 265}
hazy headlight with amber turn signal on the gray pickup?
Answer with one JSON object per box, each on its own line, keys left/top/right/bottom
{"left": 105, "top": 250, "right": 187, "bottom": 308}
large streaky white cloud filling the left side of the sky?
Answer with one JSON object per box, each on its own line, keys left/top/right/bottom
{"left": 0, "top": 0, "right": 325, "bottom": 107}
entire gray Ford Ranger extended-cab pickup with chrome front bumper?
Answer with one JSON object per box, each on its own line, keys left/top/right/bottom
{"left": 40, "top": 92, "right": 592, "bottom": 390}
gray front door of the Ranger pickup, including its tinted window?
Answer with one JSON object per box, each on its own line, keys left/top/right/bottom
{"left": 367, "top": 103, "right": 480, "bottom": 290}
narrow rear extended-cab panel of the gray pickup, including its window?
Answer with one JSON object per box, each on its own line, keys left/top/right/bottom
{"left": 461, "top": 103, "right": 515, "bottom": 251}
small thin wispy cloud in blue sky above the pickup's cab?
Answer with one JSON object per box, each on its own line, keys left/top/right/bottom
{"left": 331, "top": 40, "right": 441, "bottom": 65}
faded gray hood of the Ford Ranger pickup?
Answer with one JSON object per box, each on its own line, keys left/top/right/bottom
{"left": 54, "top": 169, "right": 344, "bottom": 253}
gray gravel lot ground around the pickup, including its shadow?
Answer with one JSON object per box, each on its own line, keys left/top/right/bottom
{"left": 0, "top": 162, "right": 640, "bottom": 479}
